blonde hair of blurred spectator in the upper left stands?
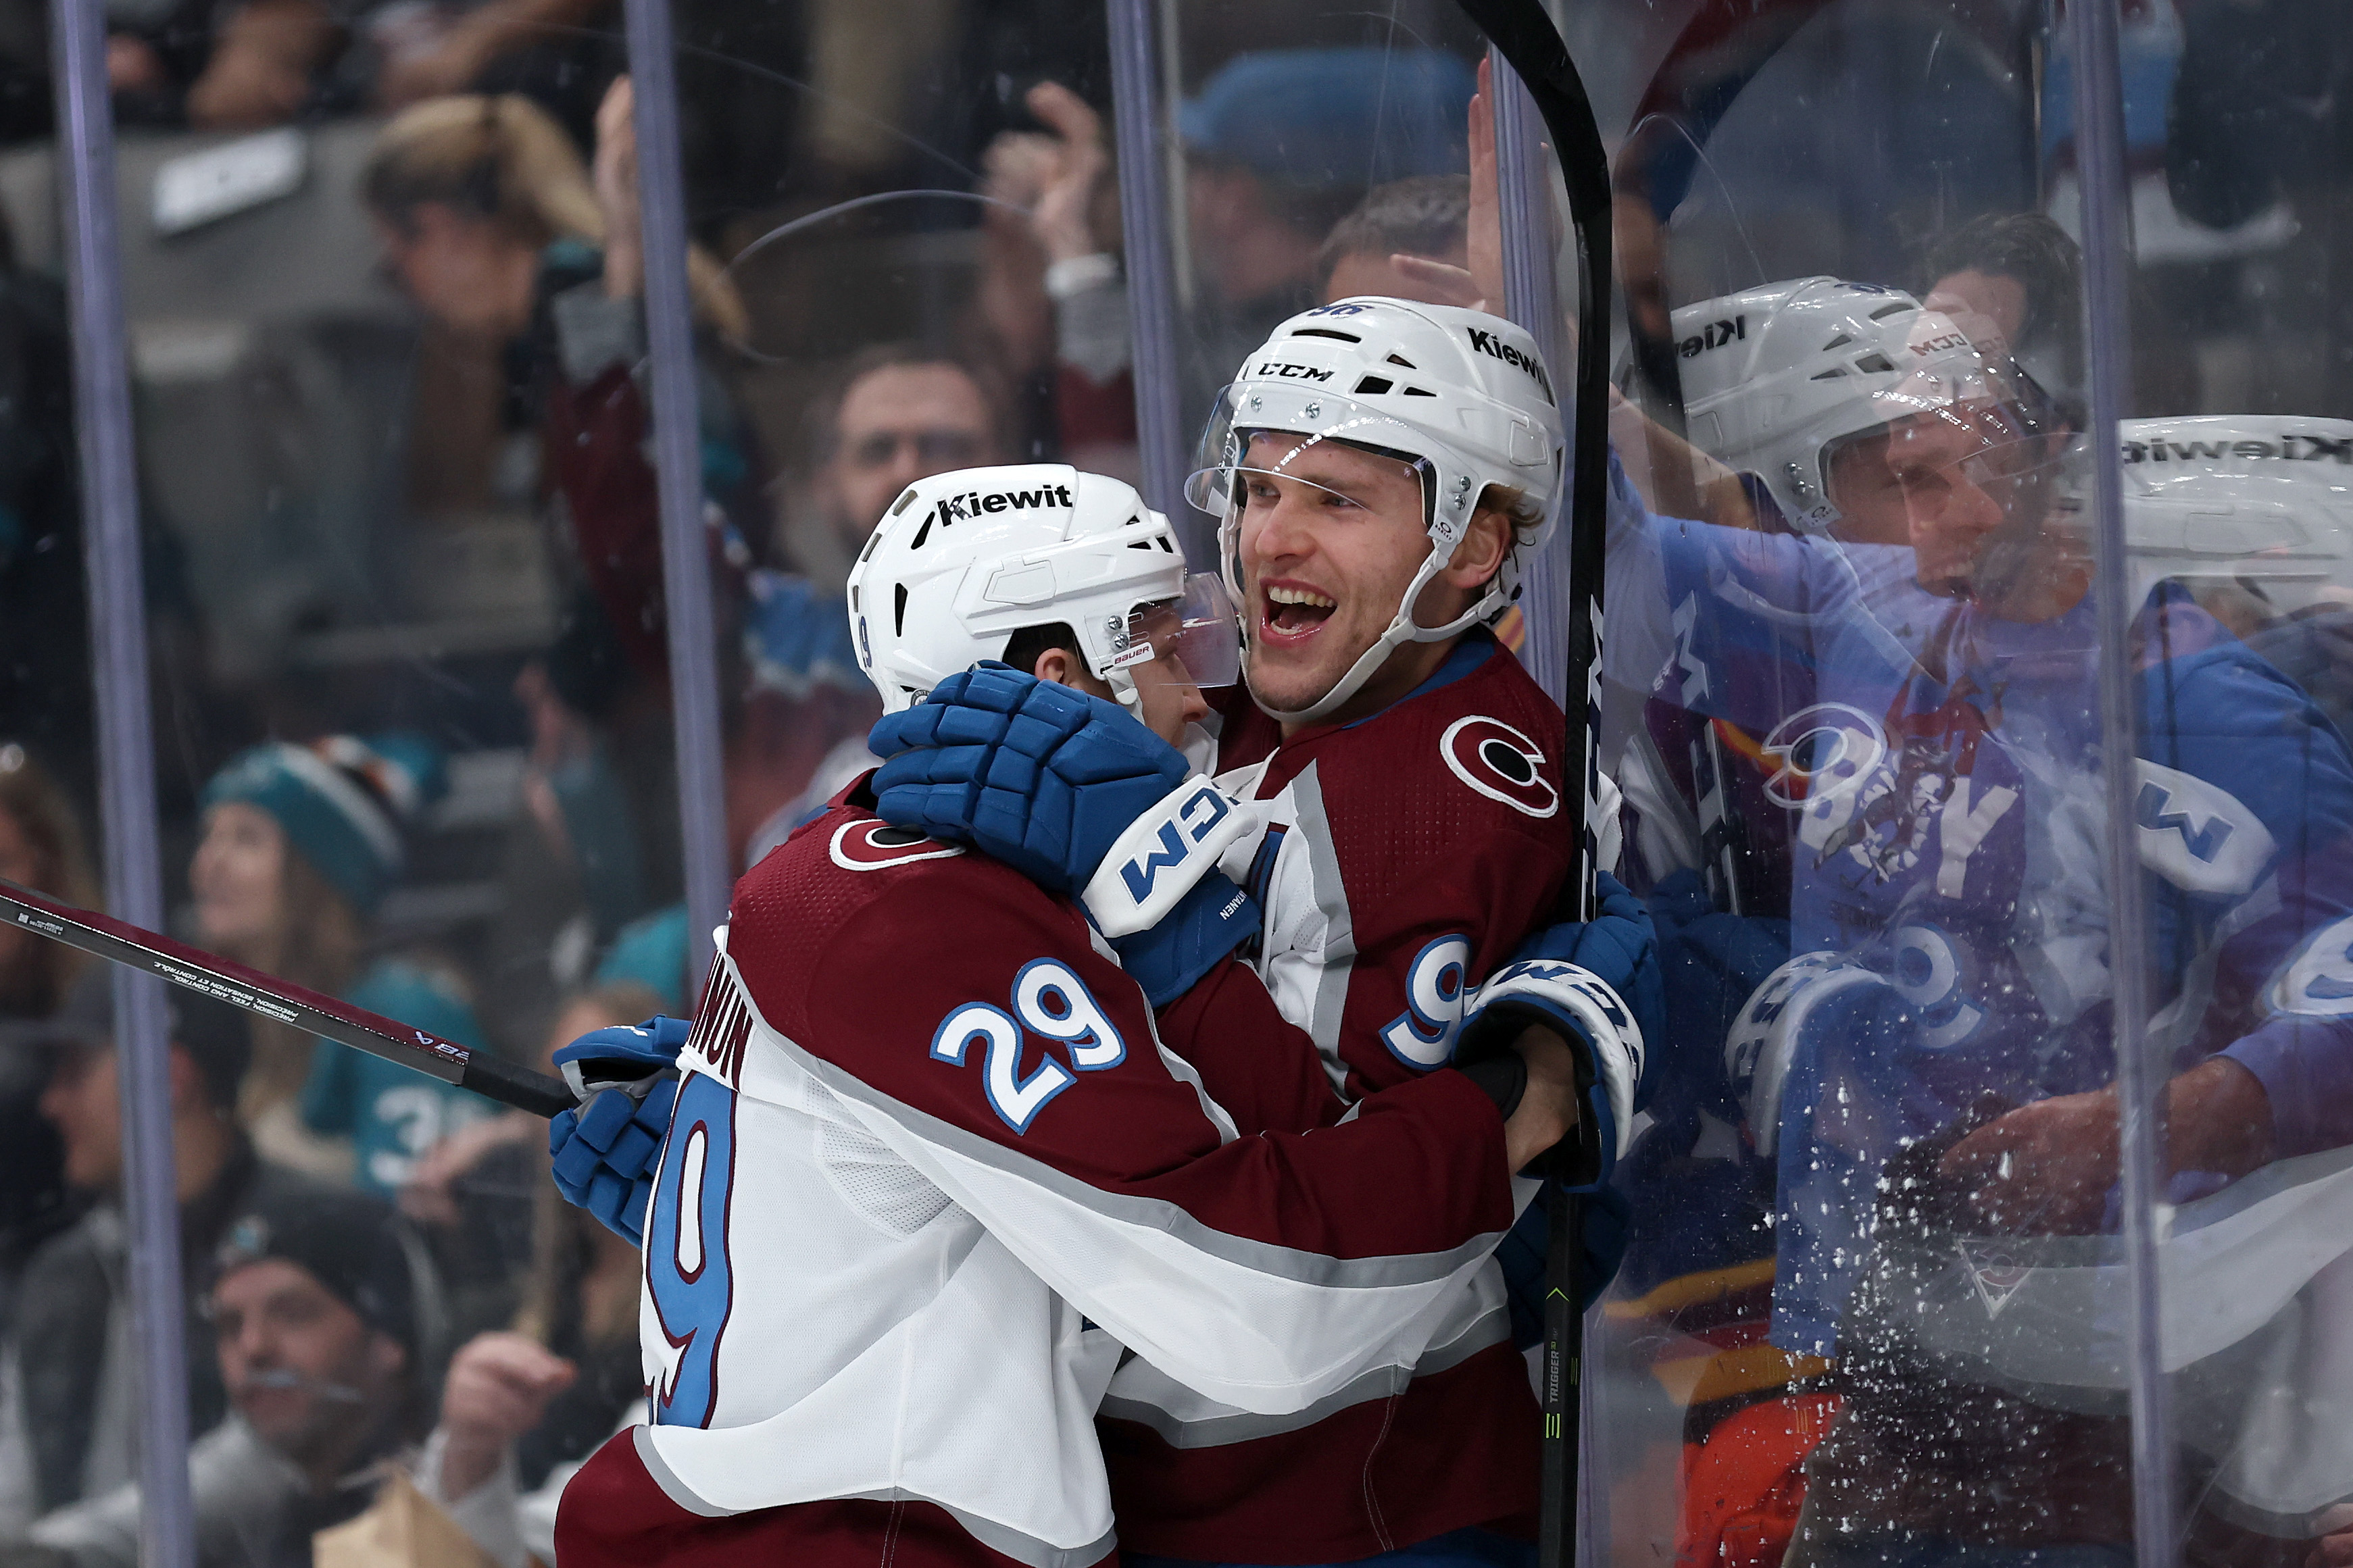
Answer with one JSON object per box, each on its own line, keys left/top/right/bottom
{"left": 360, "top": 92, "right": 751, "bottom": 343}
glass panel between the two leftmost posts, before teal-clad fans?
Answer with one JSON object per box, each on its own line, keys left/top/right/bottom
{"left": 0, "top": 0, "right": 678, "bottom": 1561}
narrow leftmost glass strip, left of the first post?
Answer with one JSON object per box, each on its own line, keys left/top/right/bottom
{"left": 0, "top": 245, "right": 120, "bottom": 1538}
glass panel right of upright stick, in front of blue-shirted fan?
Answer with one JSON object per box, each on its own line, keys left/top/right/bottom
{"left": 1583, "top": 0, "right": 2155, "bottom": 1563}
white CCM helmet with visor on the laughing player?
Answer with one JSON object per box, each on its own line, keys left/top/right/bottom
{"left": 1186, "top": 296, "right": 1562, "bottom": 722}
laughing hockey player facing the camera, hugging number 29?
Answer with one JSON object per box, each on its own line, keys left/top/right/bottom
{"left": 875, "top": 299, "right": 1656, "bottom": 1563}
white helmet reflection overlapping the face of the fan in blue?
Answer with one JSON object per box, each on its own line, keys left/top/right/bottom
{"left": 1673, "top": 278, "right": 2050, "bottom": 534}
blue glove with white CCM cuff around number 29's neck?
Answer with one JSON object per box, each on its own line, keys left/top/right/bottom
{"left": 868, "top": 661, "right": 1249, "bottom": 936}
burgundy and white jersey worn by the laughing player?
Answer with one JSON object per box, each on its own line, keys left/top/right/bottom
{"left": 1101, "top": 635, "right": 1572, "bottom": 1563}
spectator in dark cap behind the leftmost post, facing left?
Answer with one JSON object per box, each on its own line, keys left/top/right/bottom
{"left": 0, "top": 982, "right": 303, "bottom": 1530}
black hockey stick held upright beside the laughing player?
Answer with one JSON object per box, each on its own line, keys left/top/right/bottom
{"left": 1461, "top": 0, "right": 1610, "bottom": 1568}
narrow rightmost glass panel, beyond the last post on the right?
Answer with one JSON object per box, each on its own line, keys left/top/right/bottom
{"left": 2108, "top": 2, "right": 2353, "bottom": 1563}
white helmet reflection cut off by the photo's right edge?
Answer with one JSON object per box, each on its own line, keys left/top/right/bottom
{"left": 2115, "top": 413, "right": 2353, "bottom": 613}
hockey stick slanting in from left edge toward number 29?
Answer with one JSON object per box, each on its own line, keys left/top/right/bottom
{"left": 0, "top": 882, "right": 576, "bottom": 1117}
